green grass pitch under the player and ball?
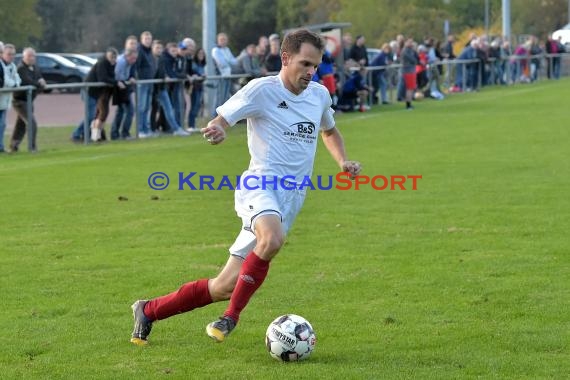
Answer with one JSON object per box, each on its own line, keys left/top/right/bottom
{"left": 0, "top": 80, "right": 570, "bottom": 379}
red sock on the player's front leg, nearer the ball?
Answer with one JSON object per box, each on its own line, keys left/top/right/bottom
{"left": 224, "top": 251, "right": 269, "bottom": 322}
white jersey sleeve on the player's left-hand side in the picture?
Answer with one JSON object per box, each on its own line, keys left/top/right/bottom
{"left": 216, "top": 81, "right": 263, "bottom": 126}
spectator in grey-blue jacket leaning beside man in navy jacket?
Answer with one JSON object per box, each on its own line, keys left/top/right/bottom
{"left": 111, "top": 48, "right": 138, "bottom": 140}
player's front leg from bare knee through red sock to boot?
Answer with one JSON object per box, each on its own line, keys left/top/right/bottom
{"left": 206, "top": 215, "right": 285, "bottom": 342}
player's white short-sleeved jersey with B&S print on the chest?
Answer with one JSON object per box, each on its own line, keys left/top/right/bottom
{"left": 216, "top": 75, "right": 335, "bottom": 183}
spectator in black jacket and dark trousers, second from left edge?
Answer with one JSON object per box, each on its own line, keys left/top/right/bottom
{"left": 10, "top": 48, "right": 46, "bottom": 152}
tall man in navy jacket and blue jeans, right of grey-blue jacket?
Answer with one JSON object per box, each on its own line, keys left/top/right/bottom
{"left": 135, "top": 31, "right": 156, "bottom": 138}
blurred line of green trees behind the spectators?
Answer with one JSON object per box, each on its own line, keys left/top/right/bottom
{"left": 0, "top": 0, "right": 568, "bottom": 52}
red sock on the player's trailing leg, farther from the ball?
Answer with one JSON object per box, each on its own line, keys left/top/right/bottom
{"left": 144, "top": 278, "right": 212, "bottom": 321}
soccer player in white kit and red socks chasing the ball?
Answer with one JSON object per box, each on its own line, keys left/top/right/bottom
{"left": 131, "top": 29, "right": 360, "bottom": 345}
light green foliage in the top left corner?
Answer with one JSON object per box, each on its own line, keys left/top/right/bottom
{"left": 0, "top": 0, "right": 42, "bottom": 50}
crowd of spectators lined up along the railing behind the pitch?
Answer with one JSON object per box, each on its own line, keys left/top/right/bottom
{"left": 0, "top": 31, "right": 565, "bottom": 152}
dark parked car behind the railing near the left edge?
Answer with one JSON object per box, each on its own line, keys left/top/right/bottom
{"left": 15, "top": 53, "right": 89, "bottom": 93}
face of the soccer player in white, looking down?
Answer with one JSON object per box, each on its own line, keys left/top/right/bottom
{"left": 281, "top": 43, "right": 322, "bottom": 94}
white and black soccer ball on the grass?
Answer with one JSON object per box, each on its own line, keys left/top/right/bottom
{"left": 265, "top": 314, "right": 317, "bottom": 362}
